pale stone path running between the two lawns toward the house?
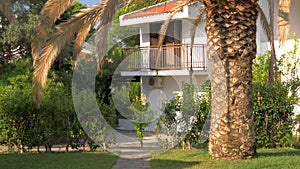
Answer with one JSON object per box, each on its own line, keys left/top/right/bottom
{"left": 110, "top": 131, "right": 160, "bottom": 169}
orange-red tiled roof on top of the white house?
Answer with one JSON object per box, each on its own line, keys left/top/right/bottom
{"left": 123, "top": 0, "right": 187, "bottom": 20}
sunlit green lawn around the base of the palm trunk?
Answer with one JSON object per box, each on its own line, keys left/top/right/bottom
{"left": 151, "top": 149, "right": 300, "bottom": 169}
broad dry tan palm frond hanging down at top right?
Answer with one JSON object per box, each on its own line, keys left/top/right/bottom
{"left": 277, "top": 0, "right": 291, "bottom": 46}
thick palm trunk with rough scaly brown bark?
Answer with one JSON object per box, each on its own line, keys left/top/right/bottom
{"left": 205, "top": 0, "right": 258, "bottom": 160}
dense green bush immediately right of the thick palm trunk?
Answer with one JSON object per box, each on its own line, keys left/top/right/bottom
{"left": 253, "top": 83, "right": 296, "bottom": 148}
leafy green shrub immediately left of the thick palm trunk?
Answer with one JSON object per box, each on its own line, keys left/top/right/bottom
{"left": 156, "top": 82, "right": 211, "bottom": 148}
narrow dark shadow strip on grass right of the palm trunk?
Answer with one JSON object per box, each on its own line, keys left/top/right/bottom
{"left": 257, "top": 149, "right": 300, "bottom": 157}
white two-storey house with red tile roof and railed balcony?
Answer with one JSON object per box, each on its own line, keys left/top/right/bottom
{"left": 119, "top": 0, "right": 300, "bottom": 131}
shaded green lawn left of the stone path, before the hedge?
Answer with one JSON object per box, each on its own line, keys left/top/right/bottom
{"left": 0, "top": 152, "right": 118, "bottom": 169}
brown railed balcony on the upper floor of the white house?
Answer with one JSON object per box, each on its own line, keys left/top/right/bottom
{"left": 122, "top": 44, "right": 207, "bottom": 71}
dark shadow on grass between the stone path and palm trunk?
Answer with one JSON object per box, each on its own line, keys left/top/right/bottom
{"left": 151, "top": 159, "right": 200, "bottom": 169}
